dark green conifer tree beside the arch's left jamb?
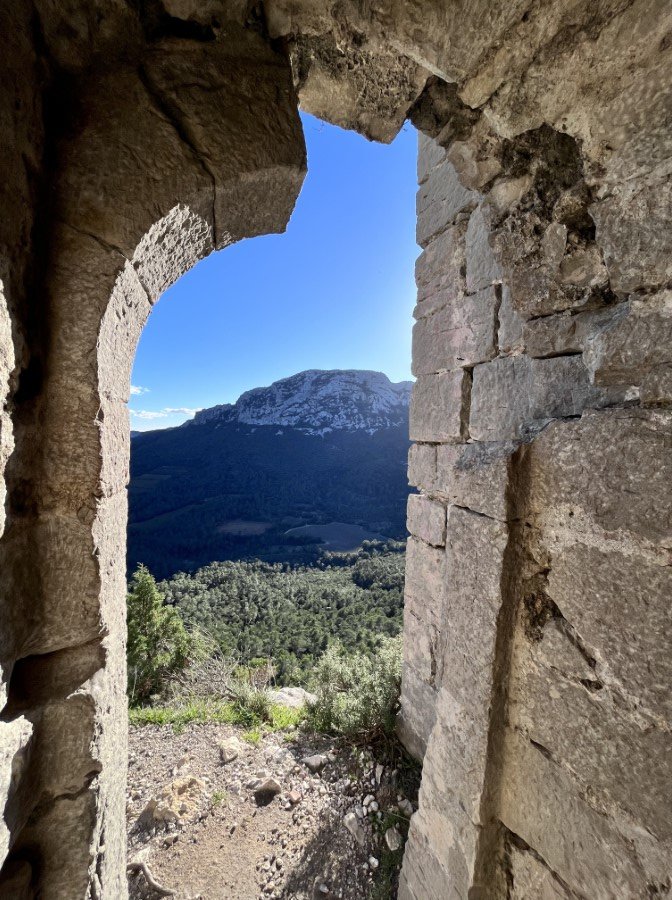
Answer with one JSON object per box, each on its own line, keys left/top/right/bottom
{"left": 127, "top": 566, "right": 193, "bottom": 704}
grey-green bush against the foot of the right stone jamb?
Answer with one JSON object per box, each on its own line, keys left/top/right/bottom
{"left": 308, "top": 637, "right": 401, "bottom": 740}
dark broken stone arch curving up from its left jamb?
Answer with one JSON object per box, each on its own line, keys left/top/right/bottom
{"left": 0, "top": 25, "right": 305, "bottom": 897}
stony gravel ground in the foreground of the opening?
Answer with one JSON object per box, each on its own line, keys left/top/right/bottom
{"left": 127, "top": 724, "right": 415, "bottom": 900}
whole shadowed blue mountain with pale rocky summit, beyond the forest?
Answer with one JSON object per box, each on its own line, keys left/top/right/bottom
{"left": 128, "top": 370, "right": 411, "bottom": 577}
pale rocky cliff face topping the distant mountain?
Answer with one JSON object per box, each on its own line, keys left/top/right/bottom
{"left": 188, "top": 369, "right": 412, "bottom": 434}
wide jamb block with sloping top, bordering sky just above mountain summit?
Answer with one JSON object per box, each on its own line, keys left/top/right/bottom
{"left": 413, "top": 287, "right": 499, "bottom": 376}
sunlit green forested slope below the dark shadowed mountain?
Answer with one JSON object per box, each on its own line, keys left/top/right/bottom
{"left": 160, "top": 542, "right": 404, "bottom": 684}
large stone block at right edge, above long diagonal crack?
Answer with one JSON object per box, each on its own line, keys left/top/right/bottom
{"left": 548, "top": 544, "right": 672, "bottom": 724}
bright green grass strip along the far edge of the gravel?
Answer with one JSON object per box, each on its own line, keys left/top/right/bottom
{"left": 128, "top": 699, "right": 304, "bottom": 743}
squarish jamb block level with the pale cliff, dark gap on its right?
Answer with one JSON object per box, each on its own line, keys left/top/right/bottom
{"left": 409, "top": 369, "right": 471, "bottom": 443}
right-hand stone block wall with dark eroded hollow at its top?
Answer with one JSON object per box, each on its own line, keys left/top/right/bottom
{"left": 401, "top": 128, "right": 672, "bottom": 900}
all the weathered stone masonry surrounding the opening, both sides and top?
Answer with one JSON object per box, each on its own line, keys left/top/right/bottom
{"left": 0, "top": 0, "right": 672, "bottom": 900}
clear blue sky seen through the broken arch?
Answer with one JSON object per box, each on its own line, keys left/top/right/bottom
{"left": 130, "top": 115, "right": 419, "bottom": 430}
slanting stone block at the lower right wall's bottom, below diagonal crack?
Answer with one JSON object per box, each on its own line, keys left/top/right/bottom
{"left": 500, "top": 730, "right": 647, "bottom": 900}
